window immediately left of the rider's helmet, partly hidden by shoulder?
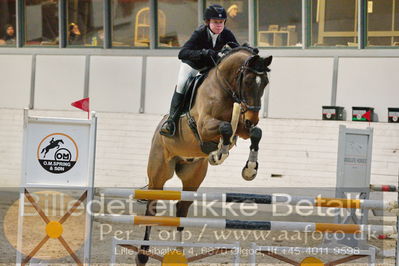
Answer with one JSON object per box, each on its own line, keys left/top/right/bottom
{"left": 158, "top": 0, "right": 198, "bottom": 47}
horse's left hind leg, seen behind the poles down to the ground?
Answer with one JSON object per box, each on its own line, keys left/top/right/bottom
{"left": 136, "top": 140, "right": 175, "bottom": 265}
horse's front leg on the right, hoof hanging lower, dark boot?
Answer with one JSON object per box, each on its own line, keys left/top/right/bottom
{"left": 241, "top": 127, "right": 262, "bottom": 181}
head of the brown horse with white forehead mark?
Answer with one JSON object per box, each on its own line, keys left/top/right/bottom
{"left": 235, "top": 54, "right": 273, "bottom": 128}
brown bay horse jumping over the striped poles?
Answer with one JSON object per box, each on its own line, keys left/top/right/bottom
{"left": 136, "top": 47, "right": 272, "bottom": 265}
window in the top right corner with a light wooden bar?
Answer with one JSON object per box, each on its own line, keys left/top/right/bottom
{"left": 367, "top": 0, "right": 399, "bottom": 46}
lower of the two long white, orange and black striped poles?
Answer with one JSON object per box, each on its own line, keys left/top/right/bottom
{"left": 94, "top": 214, "right": 396, "bottom": 234}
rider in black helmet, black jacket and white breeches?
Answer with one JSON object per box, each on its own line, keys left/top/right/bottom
{"left": 160, "top": 5, "right": 238, "bottom": 137}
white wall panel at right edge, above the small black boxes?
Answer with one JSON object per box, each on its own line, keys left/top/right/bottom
{"left": 337, "top": 58, "right": 399, "bottom": 122}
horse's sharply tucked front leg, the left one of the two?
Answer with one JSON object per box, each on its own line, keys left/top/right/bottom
{"left": 208, "top": 122, "right": 233, "bottom": 165}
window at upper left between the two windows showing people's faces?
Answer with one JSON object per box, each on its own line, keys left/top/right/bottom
{"left": 25, "top": 0, "right": 59, "bottom": 45}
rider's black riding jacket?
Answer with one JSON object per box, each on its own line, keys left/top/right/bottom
{"left": 179, "top": 25, "right": 238, "bottom": 71}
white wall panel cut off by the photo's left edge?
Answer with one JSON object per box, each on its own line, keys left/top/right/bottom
{"left": 0, "top": 55, "right": 32, "bottom": 108}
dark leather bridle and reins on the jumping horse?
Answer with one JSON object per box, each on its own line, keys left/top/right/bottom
{"left": 216, "top": 55, "right": 267, "bottom": 114}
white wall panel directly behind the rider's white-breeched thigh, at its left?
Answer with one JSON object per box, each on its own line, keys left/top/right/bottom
{"left": 145, "top": 57, "right": 181, "bottom": 114}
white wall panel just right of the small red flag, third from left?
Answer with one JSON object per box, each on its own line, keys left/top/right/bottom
{"left": 89, "top": 56, "right": 142, "bottom": 113}
